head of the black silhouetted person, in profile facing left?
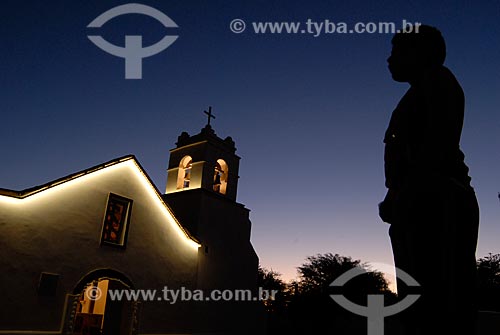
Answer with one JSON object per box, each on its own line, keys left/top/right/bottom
{"left": 387, "top": 25, "right": 446, "bottom": 82}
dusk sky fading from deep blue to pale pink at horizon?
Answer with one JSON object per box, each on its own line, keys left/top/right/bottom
{"left": 0, "top": 0, "right": 500, "bottom": 280}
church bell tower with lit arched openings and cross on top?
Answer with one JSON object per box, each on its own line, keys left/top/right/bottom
{"left": 163, "top": 108, "right": 262, "bottom": 334}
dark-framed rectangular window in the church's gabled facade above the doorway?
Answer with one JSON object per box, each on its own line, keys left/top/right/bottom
{"left": 101, "top": 193, "right": 133, "bottom": 248}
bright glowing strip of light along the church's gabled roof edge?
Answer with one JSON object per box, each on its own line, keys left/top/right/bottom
{"left": 0, "top": 157, "right": 200, "bottom": 250}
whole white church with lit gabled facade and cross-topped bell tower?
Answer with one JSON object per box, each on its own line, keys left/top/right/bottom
{"left": 0, "top": 112, "right": 264, "bottom": 335}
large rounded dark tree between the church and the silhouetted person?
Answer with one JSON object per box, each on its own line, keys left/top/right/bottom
{"left": 289, "top": 253, "right": 394, "bottom": 334}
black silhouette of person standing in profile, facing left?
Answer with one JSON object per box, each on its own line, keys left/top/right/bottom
{"left": 379, "top": 25, "right": 479, "bottom": 335}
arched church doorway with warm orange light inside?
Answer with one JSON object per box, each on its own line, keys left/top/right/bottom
{"left": 66, "top": 269, "right": 139, "bottom": 335}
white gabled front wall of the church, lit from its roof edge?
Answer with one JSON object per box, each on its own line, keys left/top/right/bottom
{"left": 0, "top": 158, "right": 199, "bottom": 332}
